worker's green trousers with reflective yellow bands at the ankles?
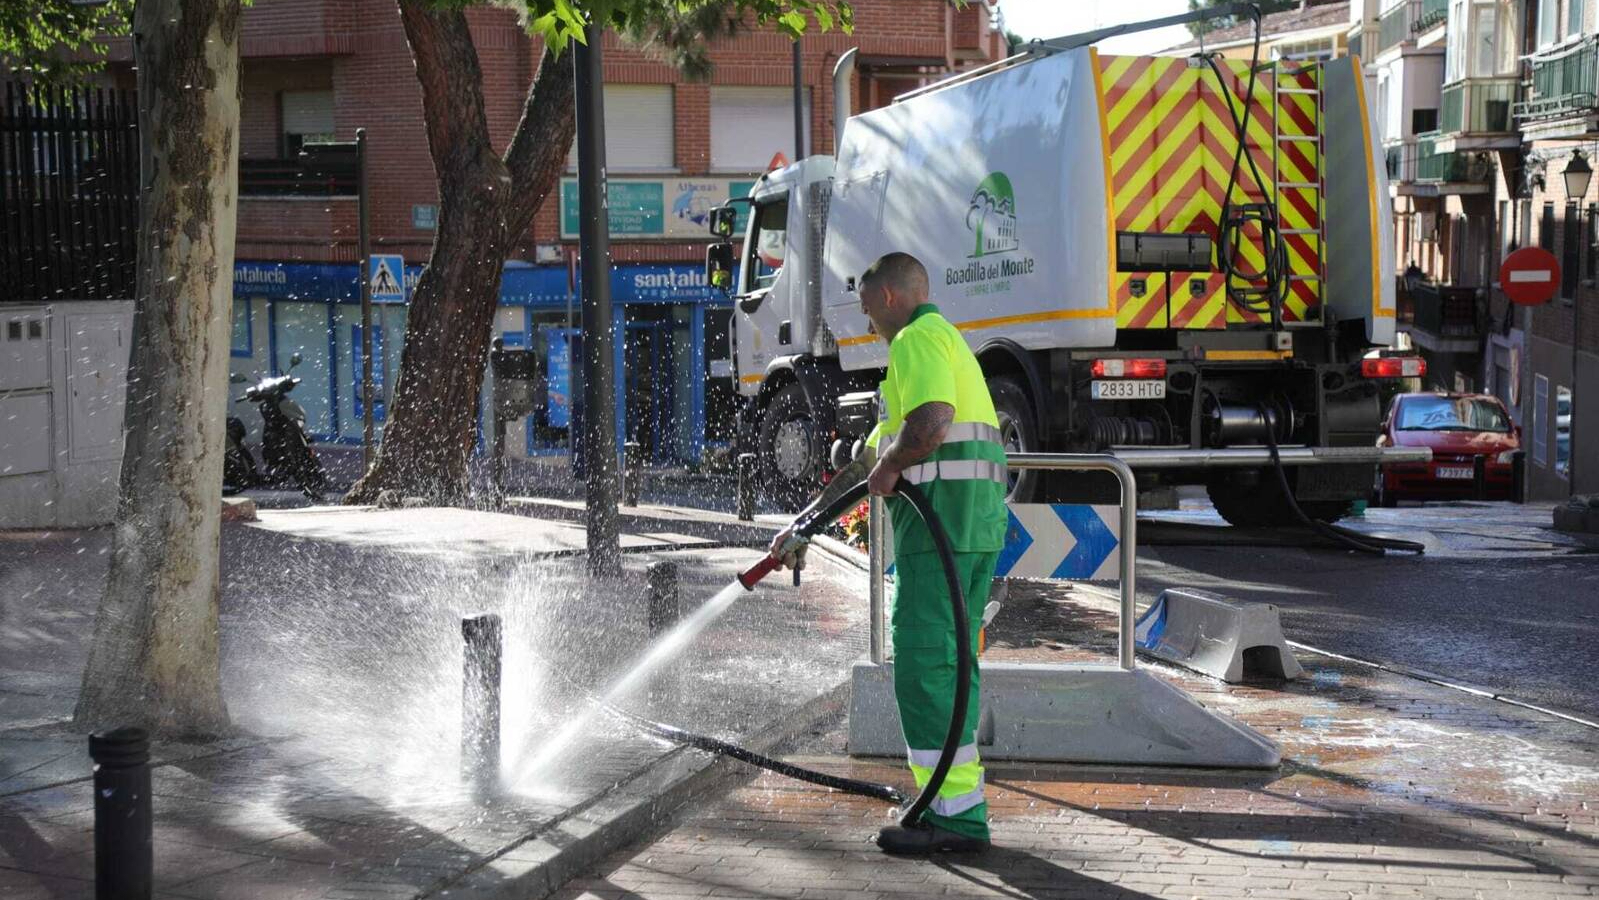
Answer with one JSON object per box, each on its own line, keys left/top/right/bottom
{"left": 892, "top": 553, "right": 999, "bottom": 839}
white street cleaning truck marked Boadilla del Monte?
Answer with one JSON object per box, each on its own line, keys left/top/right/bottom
{"left": 707, "top": 14, "right": 1422, "bottom": 526}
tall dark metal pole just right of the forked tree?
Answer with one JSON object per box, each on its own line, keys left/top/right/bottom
{"left": 572, "top": 24, "right": 622, "bottom": 577}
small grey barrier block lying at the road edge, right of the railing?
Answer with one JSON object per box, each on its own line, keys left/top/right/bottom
{"left": 1134, "top": 588, "right": 1305, "bottom": 684}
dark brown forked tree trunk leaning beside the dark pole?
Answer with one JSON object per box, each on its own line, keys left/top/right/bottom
{"left": 345, "top": 0, "right": 574, "bottom": 504}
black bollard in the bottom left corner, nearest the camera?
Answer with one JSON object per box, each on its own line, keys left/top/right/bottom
{"left": 90, "top": 727, "right": 154, "bottom": 900}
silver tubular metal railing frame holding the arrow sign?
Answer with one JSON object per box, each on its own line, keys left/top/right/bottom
{"left": 867, "top": 452, "right": 1138, "bottom": 671}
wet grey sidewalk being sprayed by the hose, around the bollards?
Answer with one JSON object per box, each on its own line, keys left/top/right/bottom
{"left": 0, "top": 508, "right": 865, "bottom": 900}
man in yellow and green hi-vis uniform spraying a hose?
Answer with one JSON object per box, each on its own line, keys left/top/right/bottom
{"left": 772, "top": 253, "right": 1007, "bottom": 854}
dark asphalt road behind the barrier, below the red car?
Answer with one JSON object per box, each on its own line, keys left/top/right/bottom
{"left": 1138, "top": 502, "right": 1599, "bottom": 721}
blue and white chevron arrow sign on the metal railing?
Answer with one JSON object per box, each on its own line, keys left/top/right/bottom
{"left": 995, "top": 504, "right": 1121, "bottom": 580}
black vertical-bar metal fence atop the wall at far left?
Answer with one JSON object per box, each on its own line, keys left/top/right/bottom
{"left": 0, "top": 82, "right": 139, "bottom": 302}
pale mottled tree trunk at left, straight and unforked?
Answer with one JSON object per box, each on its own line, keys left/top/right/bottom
{"left": 74, "top": 0, "right": 240, "bottom": 734}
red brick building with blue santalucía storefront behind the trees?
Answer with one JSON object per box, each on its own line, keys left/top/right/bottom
{"left": 96, "top": 0, "right": 1004, "bottom": 465}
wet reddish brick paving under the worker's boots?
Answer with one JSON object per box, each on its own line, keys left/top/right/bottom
{"left": 558, "top": 585, "right": 1599, "bottom": 900}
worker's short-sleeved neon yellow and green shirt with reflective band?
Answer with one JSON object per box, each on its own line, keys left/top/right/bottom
{"left": 867, "top": 304, "right": 1009, "bottom": 556}
